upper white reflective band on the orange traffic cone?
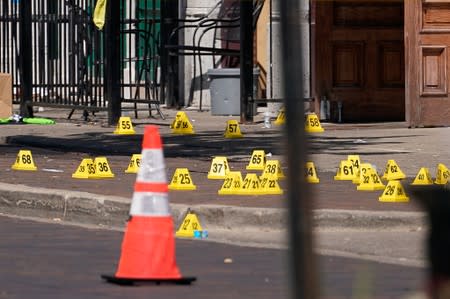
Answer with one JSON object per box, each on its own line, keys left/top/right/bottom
{"left": 136, "top": 149, "right": 167, "bottom": 183}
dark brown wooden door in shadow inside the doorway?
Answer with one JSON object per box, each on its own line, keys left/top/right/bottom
{"left": 315, "top": 0, "right": 405, "bottom": 122}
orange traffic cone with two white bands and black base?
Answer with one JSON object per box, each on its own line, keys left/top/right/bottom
{"left": 102, "top": 126, "right": 196, "bottom": 285}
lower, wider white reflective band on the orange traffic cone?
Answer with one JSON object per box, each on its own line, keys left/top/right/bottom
{"left": 130, "top": 192, "right": 171, "bottom": 216}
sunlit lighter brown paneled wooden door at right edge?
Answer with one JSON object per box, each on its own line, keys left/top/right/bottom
{"left": 405, "top": 0, "right": 450, "bottom": 127}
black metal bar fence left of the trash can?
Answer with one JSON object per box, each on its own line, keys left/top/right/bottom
{"left": 0, "top": 0, "right": 162, "bottom": 124}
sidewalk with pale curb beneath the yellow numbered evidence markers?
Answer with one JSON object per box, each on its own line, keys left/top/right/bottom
{"left": 0, "top": 108, "right": 444, "bottom": 243}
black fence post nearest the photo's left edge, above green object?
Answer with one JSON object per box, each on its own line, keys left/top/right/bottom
{"left": 19, "top": 1, "right": 33, "bottom": 117}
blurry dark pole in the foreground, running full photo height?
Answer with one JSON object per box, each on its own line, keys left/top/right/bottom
{"left": 279, "top": 0, "right": 319, "bottom": 299}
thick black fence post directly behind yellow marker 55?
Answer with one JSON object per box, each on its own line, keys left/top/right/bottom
{"left": 105, "top": 1, "right": 121, "bottom": 126}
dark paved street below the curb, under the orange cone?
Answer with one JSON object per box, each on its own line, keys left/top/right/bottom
{"left": 0, "top": 216, "right": 426, "bottom": 299}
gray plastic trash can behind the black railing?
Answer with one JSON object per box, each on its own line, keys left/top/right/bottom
{"left": 207, "top": 68, "right": 259, "bottom": 115}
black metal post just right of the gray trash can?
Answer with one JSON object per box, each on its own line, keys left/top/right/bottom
{"left": 240, "top": 0, "right": 253, "bottom": 123}
